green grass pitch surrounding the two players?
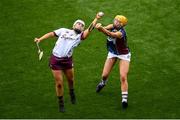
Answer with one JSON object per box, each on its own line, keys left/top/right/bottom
{"left": 0, "top": 0, "right": 180, "bottom": 118}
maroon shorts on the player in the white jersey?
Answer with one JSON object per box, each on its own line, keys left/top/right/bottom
{"left": 49, "top": 55, "right": 73, "bottom": 70}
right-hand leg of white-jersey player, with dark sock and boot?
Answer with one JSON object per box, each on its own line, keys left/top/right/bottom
{"left": 64, "top": 68, "right": 76, "bottom": 104}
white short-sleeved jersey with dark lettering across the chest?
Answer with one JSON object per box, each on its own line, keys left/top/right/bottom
{"left": 53, "top": 28, "right": 82, "bottom": 57}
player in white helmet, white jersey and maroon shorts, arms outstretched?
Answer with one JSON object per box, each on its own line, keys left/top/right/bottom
{"left": 34, "top": 14, "right": 102, "bottom": 112}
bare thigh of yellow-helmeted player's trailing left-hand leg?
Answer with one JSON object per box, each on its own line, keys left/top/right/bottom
{"left": 103, "top": 58, "right": 117, "bottom": 75}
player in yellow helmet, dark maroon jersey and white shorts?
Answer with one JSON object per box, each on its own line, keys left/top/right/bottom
{"left": 96, "top": 15, "right": 131, "bottom": 109}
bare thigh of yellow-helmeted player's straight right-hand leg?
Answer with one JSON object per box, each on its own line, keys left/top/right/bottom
{"left": 119, "top": 60, "right": 130, "bottom": 76}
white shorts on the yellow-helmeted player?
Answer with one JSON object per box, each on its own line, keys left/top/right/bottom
{"left": 107, "top": 52, "right": 131, "bottom": 62}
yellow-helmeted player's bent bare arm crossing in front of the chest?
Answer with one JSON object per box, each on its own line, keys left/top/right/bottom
{"left": 96, "top": 23, "right": 122, "bottom": 38}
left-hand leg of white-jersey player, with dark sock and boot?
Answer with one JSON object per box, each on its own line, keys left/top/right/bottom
{"left": 52, "top": 70, "right": 65, "bottom": 112}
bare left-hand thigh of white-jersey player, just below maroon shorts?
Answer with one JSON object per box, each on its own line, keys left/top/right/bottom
{"left": 52, "top": 70, "right": 63, "bottom": 82}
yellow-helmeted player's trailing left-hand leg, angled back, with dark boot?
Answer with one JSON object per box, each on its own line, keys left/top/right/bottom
{"left": 96, "top": 58, "right": 116, "bottom": 92}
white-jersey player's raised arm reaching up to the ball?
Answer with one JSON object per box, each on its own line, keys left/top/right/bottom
{"left": 82, "top": 12, "right": 104, "bottom": 39}
